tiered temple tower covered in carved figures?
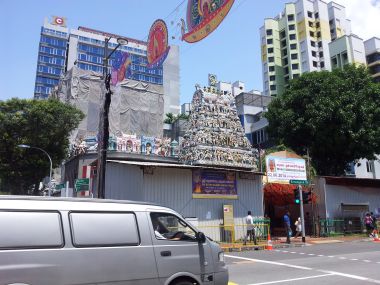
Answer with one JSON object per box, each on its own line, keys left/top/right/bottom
{"left": 179, "top": 85, "right": 258, "bottom": 171}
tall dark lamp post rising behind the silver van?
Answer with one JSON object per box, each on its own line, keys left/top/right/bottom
{"left": 96, "top": 37, "right": 128, "bottom": 199}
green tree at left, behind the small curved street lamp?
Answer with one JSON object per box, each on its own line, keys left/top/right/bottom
{"left": 0, "top": 98, "right": 84, "bottom": 194}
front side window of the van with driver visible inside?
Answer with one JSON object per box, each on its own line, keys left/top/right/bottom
{"left": 150, "top": 213, "right": 196, "bottom": 241}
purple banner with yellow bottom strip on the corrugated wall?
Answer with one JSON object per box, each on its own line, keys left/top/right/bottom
{"left": 193, "top": 170, "right": 237, "bottom": 199}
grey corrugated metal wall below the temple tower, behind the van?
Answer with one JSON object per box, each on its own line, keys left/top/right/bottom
{"left": 106, "top": 163, "right": 263, "bottom": 240}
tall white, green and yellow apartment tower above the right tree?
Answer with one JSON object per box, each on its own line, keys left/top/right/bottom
{"left": 260, "top": 0, "right": 351, "bottom": 96}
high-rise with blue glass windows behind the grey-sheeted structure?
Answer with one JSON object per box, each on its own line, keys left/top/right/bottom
{"left": 34, "top": 17, "right": 180, "bottom": 114}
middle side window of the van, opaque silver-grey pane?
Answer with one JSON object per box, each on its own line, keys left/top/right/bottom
{"left": 69, "top": 212, "right": 140, "bottom": 247}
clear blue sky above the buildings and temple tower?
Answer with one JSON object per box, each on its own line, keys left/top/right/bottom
{"left": 0, "top": 0, "right": 378, "bottom": 104}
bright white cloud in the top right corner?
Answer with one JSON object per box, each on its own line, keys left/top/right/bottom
{"left": 334, "top": 0, "right": 380, "bottom": 40}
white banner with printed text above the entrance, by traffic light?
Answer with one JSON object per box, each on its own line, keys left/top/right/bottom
{"left": 265, "top": 155, "right": 307, "bottom": 184}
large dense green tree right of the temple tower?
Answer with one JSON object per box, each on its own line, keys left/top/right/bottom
{"left": 265, "top": 65, "right": 380, "bottom": 175}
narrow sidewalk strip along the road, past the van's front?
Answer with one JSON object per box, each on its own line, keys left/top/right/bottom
{"left": 220, "top": 235, "right": 373, "bottom": 252}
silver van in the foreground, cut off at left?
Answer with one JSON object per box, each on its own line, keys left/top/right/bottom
{"left": 0, "top": 196, "right": 228, "bottom": 285}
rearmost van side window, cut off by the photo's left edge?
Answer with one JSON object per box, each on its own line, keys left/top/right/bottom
{"left": 0, "top": 211, "right": 64, "bottom": 249}
